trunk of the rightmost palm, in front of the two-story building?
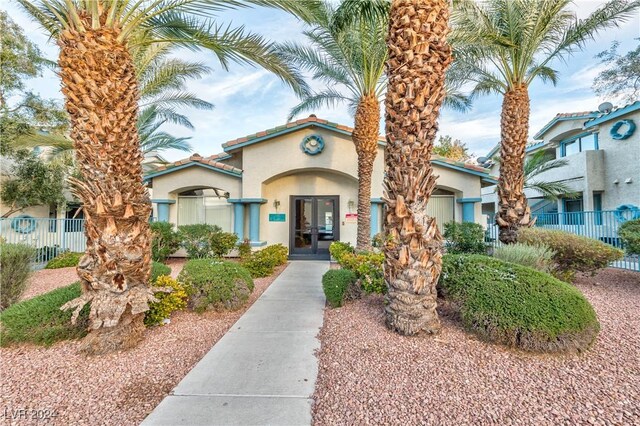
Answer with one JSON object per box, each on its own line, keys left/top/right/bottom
{"left": 496, "top": 84, "right": 535, "bottom": 244}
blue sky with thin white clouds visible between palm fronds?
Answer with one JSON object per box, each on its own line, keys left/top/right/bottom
{"left": 0, "top": 0, "right": 640, "bottom": 160}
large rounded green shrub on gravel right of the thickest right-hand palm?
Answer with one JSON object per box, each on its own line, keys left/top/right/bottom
{"left": 438, "top": 255, "right": 600, "bottom": 352}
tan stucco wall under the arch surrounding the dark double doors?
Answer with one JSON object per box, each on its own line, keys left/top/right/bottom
{"left": 260, "top": 171, "right": 358, "bottom": 247}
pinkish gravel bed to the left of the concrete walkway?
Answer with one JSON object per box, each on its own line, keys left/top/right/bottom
{"left": 0, "top": 265, "right": 286, "bottom": 425}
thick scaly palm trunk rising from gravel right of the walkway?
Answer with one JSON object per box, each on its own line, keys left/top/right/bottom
{"left": 384, "top": 0, "right": 451, "bottom": 335}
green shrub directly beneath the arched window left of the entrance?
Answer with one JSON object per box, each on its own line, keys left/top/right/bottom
{"left": 178, "top": 224, "right": 238, "bottom": 259}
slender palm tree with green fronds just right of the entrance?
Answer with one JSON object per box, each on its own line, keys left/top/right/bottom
{"left": 281, "top": 0, "right": 470, "bottom": 250}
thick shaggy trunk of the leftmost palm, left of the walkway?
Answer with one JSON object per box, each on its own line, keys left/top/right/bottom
{"left": 58, "top": 23, "right": 154, "bottom": 354}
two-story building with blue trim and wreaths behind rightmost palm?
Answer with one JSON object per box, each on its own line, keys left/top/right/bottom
{"left": 482, "top": 101, "right": 640, "bottom": 224}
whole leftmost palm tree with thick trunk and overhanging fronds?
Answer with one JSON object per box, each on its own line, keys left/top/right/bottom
{"left": 18, "top": 0, "right": 320, "bottom": 353}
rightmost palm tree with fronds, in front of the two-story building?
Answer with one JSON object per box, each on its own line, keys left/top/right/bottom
{"left": 452, "top": 0, "right": 640, "bottom": 244}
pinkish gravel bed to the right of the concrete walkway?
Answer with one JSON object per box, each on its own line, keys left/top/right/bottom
{"left": 313, "top": 269, "right": 640, "bottom": 425}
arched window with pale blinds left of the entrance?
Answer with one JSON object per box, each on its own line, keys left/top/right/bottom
{"left": 178, "top": 188, "right": 231, "bottom": 232}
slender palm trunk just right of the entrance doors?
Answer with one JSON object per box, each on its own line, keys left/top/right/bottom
{"left": 353, "top": 95, "right": 380, "bottom": 250}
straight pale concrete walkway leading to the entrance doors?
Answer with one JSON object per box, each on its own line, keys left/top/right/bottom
{"left": 142, "top": 261, "right": 329, "bottom": 425}
